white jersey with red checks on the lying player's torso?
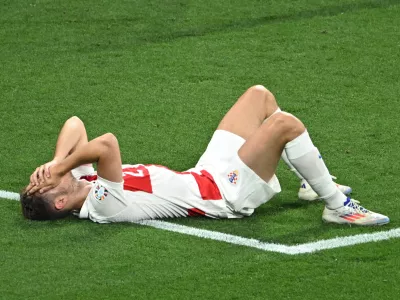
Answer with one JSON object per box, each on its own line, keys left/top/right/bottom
{"left": 72, "top": 164, "right": 242, "bottom": 223}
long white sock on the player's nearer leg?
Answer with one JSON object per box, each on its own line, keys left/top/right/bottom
{"left": 285, "top": 130, "right": 346, "bottom": 209}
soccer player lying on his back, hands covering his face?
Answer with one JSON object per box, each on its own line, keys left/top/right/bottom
{"left": 21, "top": 86, "right": 389, "bottom": 225}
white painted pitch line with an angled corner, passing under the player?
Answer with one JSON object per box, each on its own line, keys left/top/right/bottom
{"left": 0, "top": 190, "right": 400, "bottom": 255}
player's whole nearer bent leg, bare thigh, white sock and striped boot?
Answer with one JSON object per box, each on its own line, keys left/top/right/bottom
{"left": 238, "top": 112, "right": 389, "bottom": 225}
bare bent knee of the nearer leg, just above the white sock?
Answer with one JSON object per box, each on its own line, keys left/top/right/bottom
{"left": 269, "top": 112, "right": 306, "bottom": 142}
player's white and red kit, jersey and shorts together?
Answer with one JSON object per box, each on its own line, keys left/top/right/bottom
{"left": 72, "top": 130, "right": 281, "bottom": 223}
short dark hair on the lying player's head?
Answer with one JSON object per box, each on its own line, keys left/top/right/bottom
{"left": 20, "top": 189, "right": 70, "bottom": 221}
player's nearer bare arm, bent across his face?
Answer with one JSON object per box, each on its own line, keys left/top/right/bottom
{"left": 27, "top": 133, "right": 122, "bottom": 194}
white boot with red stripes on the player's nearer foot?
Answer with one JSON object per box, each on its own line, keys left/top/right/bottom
{"left": 322, "top": 198, "right": 390, "bottom": 226}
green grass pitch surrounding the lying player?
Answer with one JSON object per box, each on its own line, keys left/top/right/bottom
{"left": 0, "top": 0, "right": 400, "bottom": 299}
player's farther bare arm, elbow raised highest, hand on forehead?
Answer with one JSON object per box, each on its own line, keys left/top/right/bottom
{"left": 30, "top": 116, "right": 88, "bottom": 185}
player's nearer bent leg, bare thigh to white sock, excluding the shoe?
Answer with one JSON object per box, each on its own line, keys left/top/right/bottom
{"left": 239, "top": 112, "right": 346, "bottom": 208}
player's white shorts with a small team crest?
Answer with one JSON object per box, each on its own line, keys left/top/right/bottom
{"left": 196, "top": 130, "right": 281, "bottom": 216}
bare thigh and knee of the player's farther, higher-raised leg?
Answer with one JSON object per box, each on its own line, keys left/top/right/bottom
{"left": 217, "top": 85, "right": 278, "bottom": 140}
